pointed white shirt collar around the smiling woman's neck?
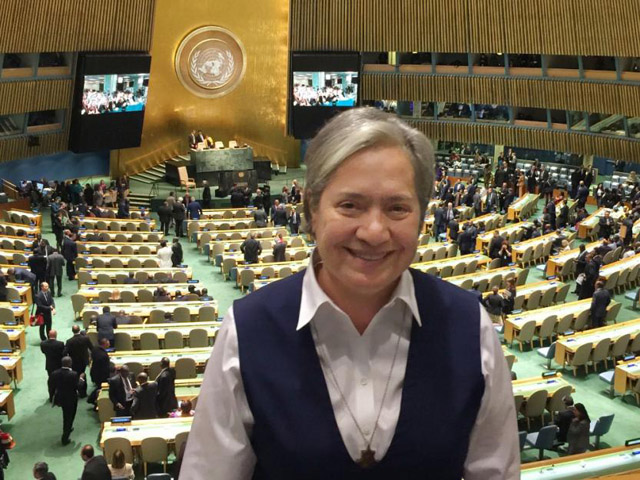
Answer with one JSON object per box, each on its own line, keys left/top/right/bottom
{"left": 296, "top": 251, "right": 422, "bottom": 330}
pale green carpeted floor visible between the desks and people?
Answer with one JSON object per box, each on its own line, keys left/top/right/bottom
{"left": 2, "top": 170, "right": 640, "bottom": 480}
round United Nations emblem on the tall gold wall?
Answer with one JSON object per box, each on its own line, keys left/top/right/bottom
{"left": 175, "top": 26, "right": 246, "bottom": 98}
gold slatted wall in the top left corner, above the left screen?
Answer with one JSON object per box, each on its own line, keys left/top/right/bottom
{"left": 0, "top": 0, "right": 156, "bottom": 53}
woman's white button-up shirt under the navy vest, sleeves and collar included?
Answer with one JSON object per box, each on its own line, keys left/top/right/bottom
{"left": 180, "top": 268, "right": 520, "bottom": 480}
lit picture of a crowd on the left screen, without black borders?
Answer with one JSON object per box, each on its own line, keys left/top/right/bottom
{"left": 81, "top": 73, "right": 149, "bottom": 115}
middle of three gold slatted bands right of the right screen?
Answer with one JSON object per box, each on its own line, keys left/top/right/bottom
{"left": 361, "top": 73, "right": 640, "bottom": 117}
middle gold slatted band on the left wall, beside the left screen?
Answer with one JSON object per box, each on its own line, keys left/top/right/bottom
{"left": 0, "top": 79, "right": 73, "bottom": 115}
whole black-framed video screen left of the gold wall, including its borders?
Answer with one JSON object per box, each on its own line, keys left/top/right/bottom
{"left": 69, "top": 53, "right": 152, "bottom": 153}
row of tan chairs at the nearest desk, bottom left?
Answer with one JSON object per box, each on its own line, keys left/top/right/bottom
{"left": 104, "top": 432, "right": 189, "bottom": 480}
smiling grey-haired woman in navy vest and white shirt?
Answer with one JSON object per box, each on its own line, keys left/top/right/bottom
{"left": 180, "top": 109, "right": 519, "bottom": 480}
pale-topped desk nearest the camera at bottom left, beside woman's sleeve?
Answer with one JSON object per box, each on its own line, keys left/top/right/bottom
{"left": 100, "top": 417, "right": 193, "bottom": 448}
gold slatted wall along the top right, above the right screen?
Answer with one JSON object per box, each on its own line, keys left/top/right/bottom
{"left": 291, "top": 0, "right": 640, "bottom": 56}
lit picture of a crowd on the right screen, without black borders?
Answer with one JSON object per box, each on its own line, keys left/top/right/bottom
{"left": 293, "top": 72, "right": 358, "bottom": 107}
